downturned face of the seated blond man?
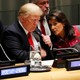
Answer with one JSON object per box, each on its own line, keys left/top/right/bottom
{"left": 22, "top": 15, "right": 40, "bottom": 32}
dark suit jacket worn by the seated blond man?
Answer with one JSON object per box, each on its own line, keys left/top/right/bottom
{"left": 2, "top": 22, "right": 40, "bottom": 62}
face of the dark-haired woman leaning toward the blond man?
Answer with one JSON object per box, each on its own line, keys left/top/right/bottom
{"left": 49, "top": 19, "right": 64, "bottom": 36}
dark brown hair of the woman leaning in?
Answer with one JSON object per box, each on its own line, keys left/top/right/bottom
{"left": 48, "top": 10, "right": 74, "bottom": 39}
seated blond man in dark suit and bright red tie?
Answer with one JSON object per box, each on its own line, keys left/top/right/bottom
{"left": 2, "top": 3, "right": 46, "bottom": 62}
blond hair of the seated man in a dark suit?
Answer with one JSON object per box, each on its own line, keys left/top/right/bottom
{"left": 18, "top": 3, "right": 43, "bottom": 16}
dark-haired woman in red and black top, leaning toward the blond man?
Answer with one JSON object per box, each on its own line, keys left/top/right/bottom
{"left": 49, "top": 10, "right": 80, "bottom": 52}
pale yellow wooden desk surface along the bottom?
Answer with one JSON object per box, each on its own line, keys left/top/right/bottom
{"left": 1, "top": 68, "right": 80, "bottom": 80}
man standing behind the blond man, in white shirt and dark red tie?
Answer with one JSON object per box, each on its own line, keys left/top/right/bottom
{"left": 29, "top": 0, "right": 53, "bottom": 60}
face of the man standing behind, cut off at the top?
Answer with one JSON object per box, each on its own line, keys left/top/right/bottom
{"left": 36, "top": 0, "right": 49, "bottom": 15}
